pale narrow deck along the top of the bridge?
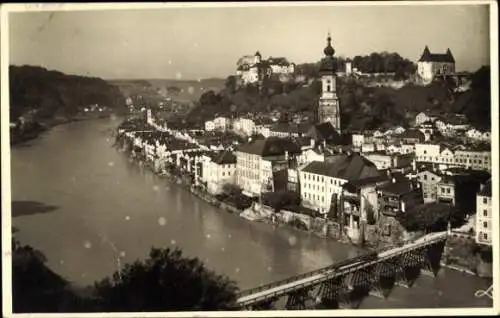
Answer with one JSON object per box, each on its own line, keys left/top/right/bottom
{"left": 237, "top": 232, "right": 446, "bottom": 305}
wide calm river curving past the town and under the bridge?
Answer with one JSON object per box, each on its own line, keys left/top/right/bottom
{"left": 11, "top": 118, "right": 491, "bottom": 308}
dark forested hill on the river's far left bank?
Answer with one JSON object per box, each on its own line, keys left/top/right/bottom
{"left": 9, "top": 65, "right": 125, "bottom": 141}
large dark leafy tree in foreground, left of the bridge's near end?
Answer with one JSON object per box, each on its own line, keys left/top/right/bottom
{"left": 95, "top": 248, "right": 238, "bottom": 312}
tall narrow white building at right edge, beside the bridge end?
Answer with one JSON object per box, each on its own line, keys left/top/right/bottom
{"left": 476, "top": 180, "right": 493, "bottom": 246}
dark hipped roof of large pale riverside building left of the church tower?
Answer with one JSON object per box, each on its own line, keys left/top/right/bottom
{"left": 238, "top": 137, "right": 301, "bottom": 157}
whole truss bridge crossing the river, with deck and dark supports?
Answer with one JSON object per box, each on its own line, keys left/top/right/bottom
{"left": 237, "top": 232, "right": 447, "bottom": 310}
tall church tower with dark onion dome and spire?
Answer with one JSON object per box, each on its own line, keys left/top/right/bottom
{"left": 318, "top": 34, "right": 341, "bottom": 134}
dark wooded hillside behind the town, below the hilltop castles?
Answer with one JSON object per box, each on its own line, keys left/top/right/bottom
{"left": 187, "top": 65, "right": 491, "bottom": 131}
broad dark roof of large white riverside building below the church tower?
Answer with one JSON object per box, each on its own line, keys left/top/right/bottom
{"left": 303, "top": 154, "right": 380, "bottom": 181}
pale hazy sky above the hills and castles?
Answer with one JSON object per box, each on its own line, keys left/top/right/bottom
{"left": 9, "top": 5, "right": 489, "bottom": 79}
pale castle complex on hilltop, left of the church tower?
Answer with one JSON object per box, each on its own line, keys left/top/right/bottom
{"left": 236, "top": 51, "right": 295, "bottom": 85}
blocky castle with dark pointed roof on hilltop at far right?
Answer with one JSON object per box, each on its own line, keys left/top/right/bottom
{"left": 417, "top": 45, "right": 455, "bottom": 82}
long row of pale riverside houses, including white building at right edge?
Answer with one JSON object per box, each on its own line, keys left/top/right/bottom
{"left": 125, "top": 108, "right": 491, "bottom": 244}
